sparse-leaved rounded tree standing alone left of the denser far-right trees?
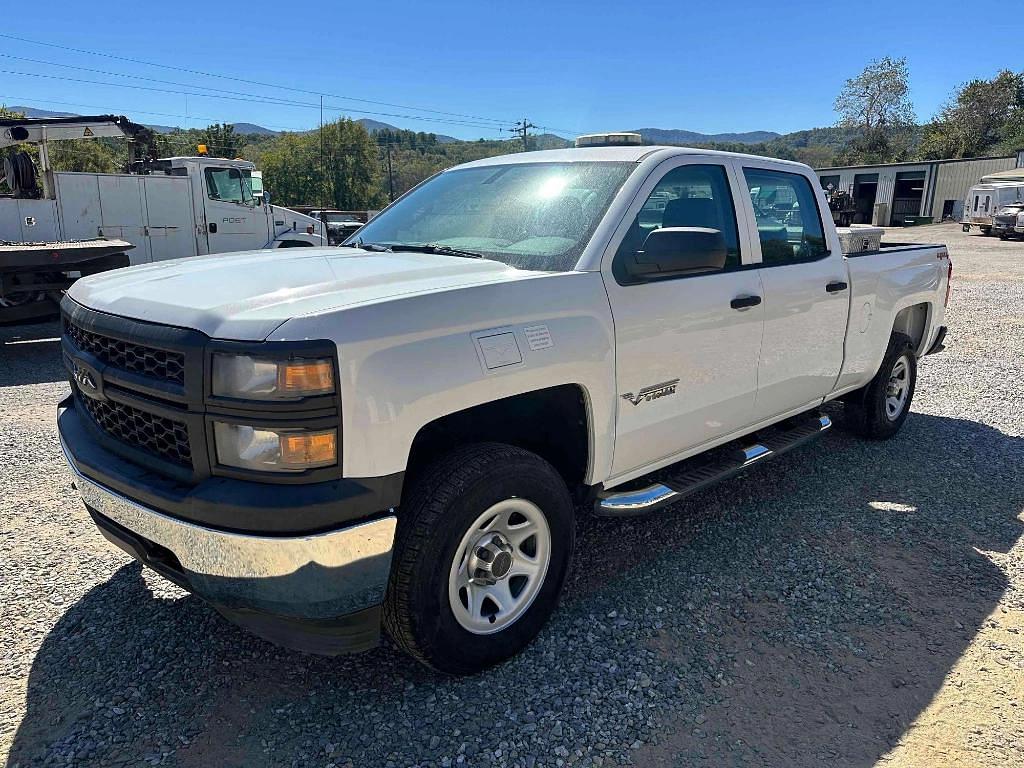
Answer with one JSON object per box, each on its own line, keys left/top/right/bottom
{"left": 835, "top": 56, "right": 914, "bottom": 163}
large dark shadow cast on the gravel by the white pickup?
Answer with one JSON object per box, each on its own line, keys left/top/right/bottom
{"left": 9, "top": 414, "right": 1024, "bottom": 768}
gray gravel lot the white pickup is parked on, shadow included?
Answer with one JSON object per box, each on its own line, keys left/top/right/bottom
{"left": 0, "top": 219, "right": 1024, "bottom": 768}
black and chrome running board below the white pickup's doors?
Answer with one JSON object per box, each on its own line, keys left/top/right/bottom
{"left": 594, "top": 414, "right": 831, "bottom": 517}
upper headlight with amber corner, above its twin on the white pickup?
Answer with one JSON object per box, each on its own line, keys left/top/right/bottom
{"left": 213, "top": 354, "right": 334, "bottom": 400}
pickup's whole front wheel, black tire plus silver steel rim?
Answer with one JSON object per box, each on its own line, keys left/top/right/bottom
{"left": 384, "top": 443, "right": 574, "bottom": 675}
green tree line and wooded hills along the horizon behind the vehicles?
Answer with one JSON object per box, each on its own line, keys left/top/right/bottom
{"left": 6, "top": 57, "right": 1024, "bottom": 202}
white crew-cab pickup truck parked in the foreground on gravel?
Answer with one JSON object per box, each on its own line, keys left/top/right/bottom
{"left": 57, "top": 138, "right": 951, "bottom": 674}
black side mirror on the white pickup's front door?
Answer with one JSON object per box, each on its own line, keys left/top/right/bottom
{"left": 627, "top": 226, "right": 728, "bottom": 280}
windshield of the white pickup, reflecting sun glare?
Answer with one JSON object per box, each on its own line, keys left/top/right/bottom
{"left": 346, "top": 163, "right": 636, "bottom": 271}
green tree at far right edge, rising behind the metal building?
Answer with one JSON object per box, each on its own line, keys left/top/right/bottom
{"left": 920, "top": 70, "right": 1024, "bottom": 160}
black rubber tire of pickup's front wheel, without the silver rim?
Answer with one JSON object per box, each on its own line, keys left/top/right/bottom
{"left": 384, "top": 443, "right": 575, "bottom": 675}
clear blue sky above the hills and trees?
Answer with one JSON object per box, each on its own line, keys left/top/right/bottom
{"left": 0, "top": 0, "right": 1024, "bottom": 138}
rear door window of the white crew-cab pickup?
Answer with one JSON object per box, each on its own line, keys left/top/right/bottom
{"left": 743, "top": 168, "right": 828, "bottom": 266}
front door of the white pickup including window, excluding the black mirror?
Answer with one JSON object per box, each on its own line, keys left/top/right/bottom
{"left": 604, "top": 158, "right": 764, "bottom": 477}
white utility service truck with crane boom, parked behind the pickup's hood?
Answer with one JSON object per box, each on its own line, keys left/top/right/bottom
{"left": 0, "top": 115, "right": 327, "bottom": 324}
